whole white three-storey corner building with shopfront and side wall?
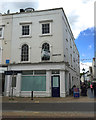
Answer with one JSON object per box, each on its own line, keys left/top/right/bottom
{"left": 2, "top": 8, "right": 80, "bottom": 97}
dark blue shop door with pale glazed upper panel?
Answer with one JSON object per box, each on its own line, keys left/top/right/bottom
{"left": 51, "top": 75, "right": 60, "bottom": 97}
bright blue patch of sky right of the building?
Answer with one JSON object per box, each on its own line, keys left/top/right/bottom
{"left": 75, "top": 27, "right": 94, "bottom": 62}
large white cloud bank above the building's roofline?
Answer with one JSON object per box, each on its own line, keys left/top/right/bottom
{"left": 0, "top": 0, "right": 95, "bottom": 38}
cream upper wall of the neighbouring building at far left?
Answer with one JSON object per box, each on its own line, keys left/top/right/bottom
{"left": 0, "top": 15, "right": 12, "bottom": 64}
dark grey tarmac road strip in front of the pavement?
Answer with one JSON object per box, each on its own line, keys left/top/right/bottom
{"left": 2, "top": 102, "right": 96, "bottom": 112}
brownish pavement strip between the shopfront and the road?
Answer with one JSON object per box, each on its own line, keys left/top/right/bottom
{"left": 2, "top": 96, "right": 96, "bottom": 103}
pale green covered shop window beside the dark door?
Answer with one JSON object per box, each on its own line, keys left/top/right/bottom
{"left": 21, "top": 76, "right": 46, "bottom": 91}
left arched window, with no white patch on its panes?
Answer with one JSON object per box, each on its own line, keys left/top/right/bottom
{"left": 21, "top": 44, "right": 29, "bottom": 61}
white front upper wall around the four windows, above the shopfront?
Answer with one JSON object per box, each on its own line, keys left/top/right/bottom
{"left": 11, "top": 10, "right": 64, "bottom": 63}
